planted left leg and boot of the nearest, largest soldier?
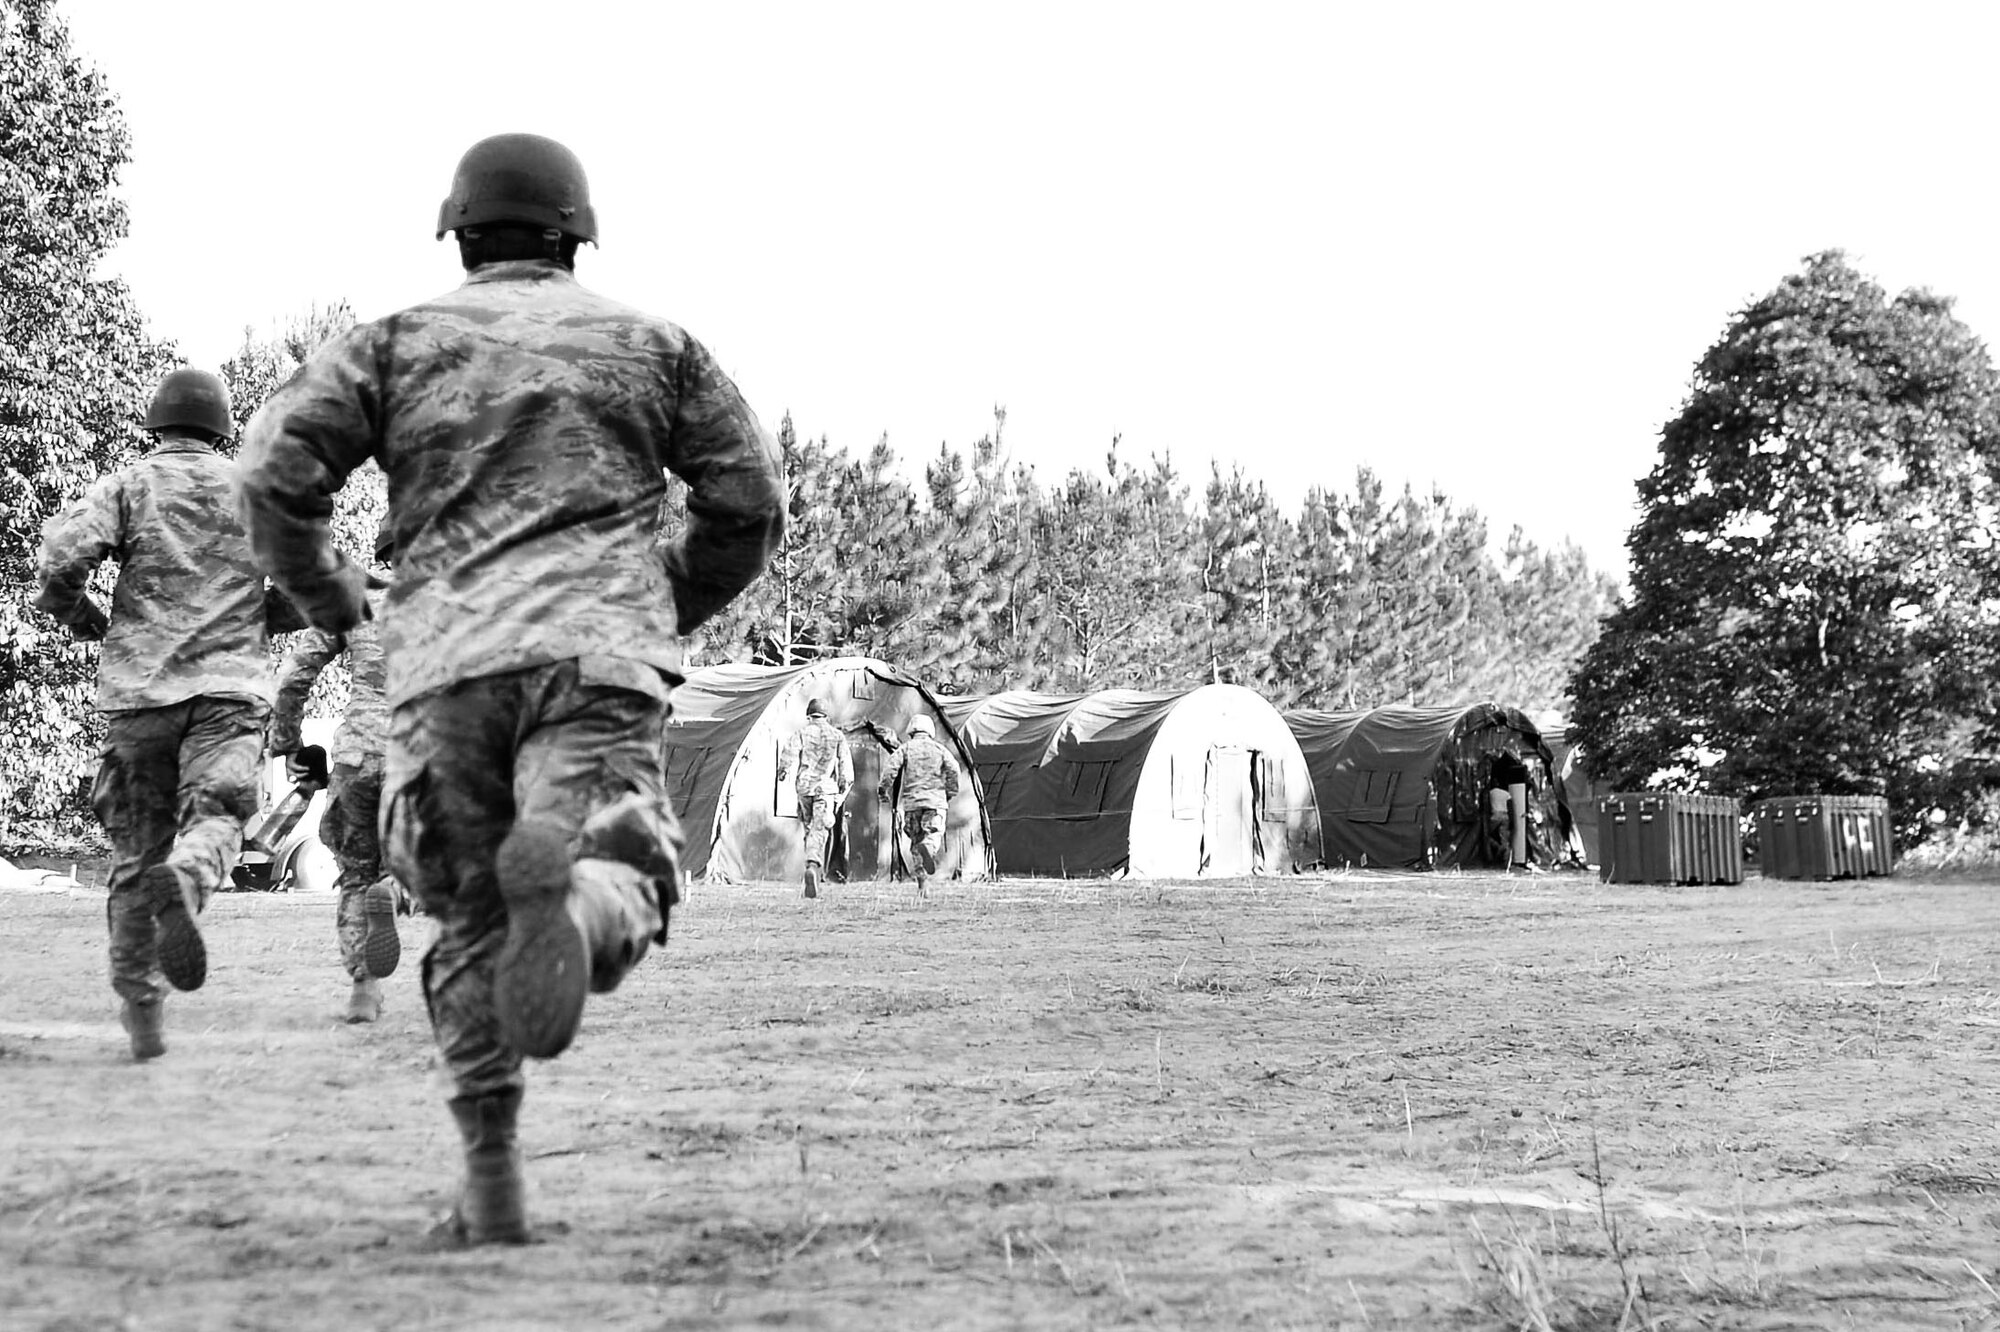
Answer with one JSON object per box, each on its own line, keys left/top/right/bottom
{"left": 382, "top": 672, "right": 528, "bottom": 1244}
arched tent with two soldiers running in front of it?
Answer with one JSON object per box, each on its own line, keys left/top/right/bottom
{"left": 666, "top": 656, "right": 992, "bottom": 882}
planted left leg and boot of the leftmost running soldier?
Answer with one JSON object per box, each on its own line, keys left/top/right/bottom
{"left": 90, "top": 704, "right": 188, "bottom": 1060}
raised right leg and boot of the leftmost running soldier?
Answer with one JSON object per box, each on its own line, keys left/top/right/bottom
{"left": 146, "top": 698, "right": 270, "bottom": 990}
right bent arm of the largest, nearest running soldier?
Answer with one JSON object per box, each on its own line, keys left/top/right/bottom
{"left": 660, "top": 338, "right": 786, "bottom": 634}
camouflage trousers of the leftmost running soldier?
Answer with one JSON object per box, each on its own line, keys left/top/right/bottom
{"left": 90, "top": 698, "right": 270, "bottom": 1002}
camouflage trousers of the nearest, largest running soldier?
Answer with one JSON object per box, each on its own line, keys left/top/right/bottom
{"left": 382, "top": 658, "right": 680, "bottom": 1096}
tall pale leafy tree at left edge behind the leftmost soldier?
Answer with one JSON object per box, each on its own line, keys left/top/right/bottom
{"left": 0, "top": 0, "right": 174, "bottom": 842}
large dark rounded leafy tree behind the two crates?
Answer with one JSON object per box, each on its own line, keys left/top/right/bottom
{"left": 1572, "top": 252, "right": 2000, "bottom": 838}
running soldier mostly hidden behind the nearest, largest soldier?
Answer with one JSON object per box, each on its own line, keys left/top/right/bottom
{"left": 266, "top": 522, "right": 402, "bottom": 1022}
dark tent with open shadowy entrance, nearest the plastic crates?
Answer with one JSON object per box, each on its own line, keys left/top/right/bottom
{"left": 1284, "top": 704, "right": 1574, "bottom": 868}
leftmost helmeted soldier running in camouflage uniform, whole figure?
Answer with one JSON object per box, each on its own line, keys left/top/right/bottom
{"left": 34, "top": 370, "right": 270, "bottom": 1060}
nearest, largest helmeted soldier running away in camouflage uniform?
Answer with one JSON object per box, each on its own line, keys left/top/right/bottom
{"left": 238, "top": 134, "right": 784, "bottom": 1244}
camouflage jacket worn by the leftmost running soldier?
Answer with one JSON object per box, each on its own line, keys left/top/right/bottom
{"left": 34, "top": 438, "right": 270, "bottom": 712}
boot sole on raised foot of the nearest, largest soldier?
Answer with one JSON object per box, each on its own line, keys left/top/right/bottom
{"left": 494, "top": 824, "right": 590, "bottom": 1060}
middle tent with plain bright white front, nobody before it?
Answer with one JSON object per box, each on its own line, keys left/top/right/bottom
{"left": 942, "top": 684, "right": 1320, "bottom": 878}
